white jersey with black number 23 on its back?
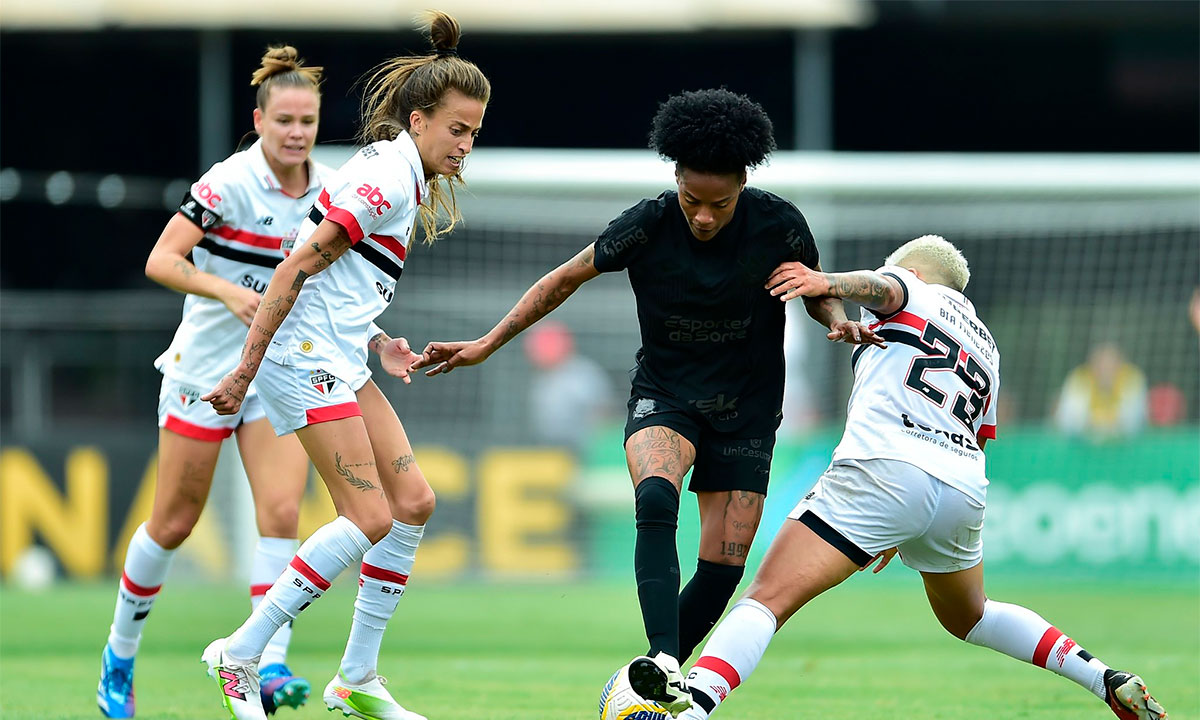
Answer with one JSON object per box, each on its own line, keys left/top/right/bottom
{"left": 833, "top": 266, "right": 1000, "bottom": 503}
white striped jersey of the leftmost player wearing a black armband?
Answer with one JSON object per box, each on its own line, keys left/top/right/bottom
{"left": 155, "top": 140, "right": 332, "bottom": 388}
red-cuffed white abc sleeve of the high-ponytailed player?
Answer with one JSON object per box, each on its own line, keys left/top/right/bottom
{"left": 325, "top": 163, "right": 416, "bottom": 242}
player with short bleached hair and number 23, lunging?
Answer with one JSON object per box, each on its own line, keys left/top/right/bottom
{"left": 679, "top": 235, "right": 1166, "bottom": 720}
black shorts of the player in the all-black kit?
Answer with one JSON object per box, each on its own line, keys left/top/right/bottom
{"left": 625, "top": 395, "right": 775, "bottom": 494}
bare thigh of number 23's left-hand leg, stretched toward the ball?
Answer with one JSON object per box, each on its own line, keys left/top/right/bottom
{"left": 746, "top": 520, "right": 858, "bottom": 626}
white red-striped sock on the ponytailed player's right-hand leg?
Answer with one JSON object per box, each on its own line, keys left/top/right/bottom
{"left": 342, "top": 520, "right": 425, "bottom": 683}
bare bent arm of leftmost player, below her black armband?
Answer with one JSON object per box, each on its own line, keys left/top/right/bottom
{"left": 146, "top": 214, "right": 259, "bottom": 325}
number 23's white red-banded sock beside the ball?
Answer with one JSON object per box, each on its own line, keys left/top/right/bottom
{"left": 688, "top": 598, "right": 776, "bottom": 718}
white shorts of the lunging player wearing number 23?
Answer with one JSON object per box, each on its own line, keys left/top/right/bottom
{"left": 788, "top": 460, "right": 984, "bottom": 572}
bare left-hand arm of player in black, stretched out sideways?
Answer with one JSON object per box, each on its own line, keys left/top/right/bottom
{"left": 410, "top": 244, "right": 600, "bottom": 376}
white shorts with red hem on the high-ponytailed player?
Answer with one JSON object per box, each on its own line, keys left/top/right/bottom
{"left": 254, "top": 358, "right": 370, "bottom": 436}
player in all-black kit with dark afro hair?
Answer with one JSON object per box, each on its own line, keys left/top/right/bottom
{"left": 414, "top": 90, "right": 878, "bottom": 715}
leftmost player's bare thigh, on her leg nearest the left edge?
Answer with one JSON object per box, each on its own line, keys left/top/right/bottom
{"left": 146, "top": 428, "right": 221, "bottom": 550}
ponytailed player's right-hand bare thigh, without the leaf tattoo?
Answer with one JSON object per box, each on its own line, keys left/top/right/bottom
{"left": 358, "top": 380, "right": 436, "bottom": 526}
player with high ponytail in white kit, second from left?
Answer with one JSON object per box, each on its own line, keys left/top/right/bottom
{"left": 202, "top": 13, "right": 491, "bottom": 720}
